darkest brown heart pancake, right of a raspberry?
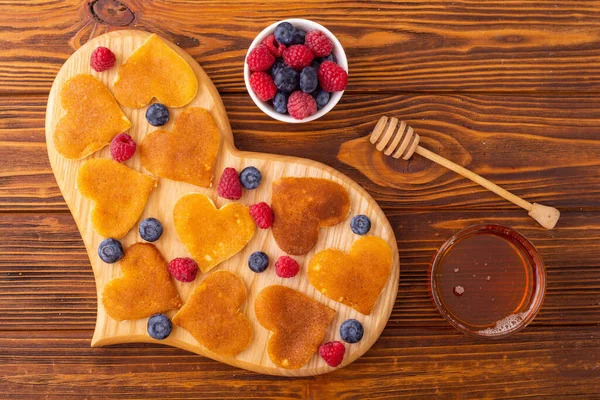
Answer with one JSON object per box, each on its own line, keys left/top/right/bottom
{"left": 271, "top": 178, "right": 350, "bottom": 255}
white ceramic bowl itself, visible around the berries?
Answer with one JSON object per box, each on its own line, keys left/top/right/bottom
{"left": 244, "top": 18, "right": 348, "bottom": 124}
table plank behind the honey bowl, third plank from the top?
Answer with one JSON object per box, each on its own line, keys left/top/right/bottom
{"left": 0, "top": 208, "right": 600, "bottom": 334}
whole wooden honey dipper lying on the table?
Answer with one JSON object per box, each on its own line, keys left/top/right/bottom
{"left": 370, "top": 117, "right": 560, "bottom": 229}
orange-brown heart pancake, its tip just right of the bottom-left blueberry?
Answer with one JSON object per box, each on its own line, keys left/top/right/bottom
{"left": 173, "top": 271, "right": 252, "bottom": 357}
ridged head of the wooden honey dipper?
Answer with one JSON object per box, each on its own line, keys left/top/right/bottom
{"left": 370, "top": 117, "right": 420, "bottom": 160}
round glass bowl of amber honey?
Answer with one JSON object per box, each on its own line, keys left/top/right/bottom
{"left": 430, "top": 225, "right": 546, "bottom": 337}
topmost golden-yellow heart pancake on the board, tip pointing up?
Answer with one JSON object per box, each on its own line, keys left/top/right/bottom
{"left": 113, "top": 35, "right": 198, "bottom": 108}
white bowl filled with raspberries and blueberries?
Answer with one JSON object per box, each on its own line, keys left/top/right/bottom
{"left": 244, "top": 18, "right": 348, "bottom": 123}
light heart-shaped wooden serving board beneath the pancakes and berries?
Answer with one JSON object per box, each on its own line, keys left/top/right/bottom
{"left": 46, "top": 31, "right": 400, "bottom": 376}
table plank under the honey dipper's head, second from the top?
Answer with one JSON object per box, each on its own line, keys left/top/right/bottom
{"left": 0, "top": 94, "right": 600, "bottom": 211}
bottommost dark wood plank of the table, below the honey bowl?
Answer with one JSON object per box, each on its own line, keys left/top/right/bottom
{"left": 0, "top": 326, "right": 600, "bottom": 400}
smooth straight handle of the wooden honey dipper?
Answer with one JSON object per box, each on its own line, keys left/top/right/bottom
{"left": 415, "top": 146, "right": 560, "bottom": 229}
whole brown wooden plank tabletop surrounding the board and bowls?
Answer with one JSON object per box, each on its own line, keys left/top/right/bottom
{"left": 0, "top": 0, "right": 600, "bottom": 399}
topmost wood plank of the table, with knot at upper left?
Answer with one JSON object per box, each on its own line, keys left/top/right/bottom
{"left": 0, "top": 0, "right": 600, "bottom": 94}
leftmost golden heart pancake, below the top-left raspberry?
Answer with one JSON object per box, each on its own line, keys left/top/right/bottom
{"left": 53, "top": 74, "right": 131, "bottom": 160}
